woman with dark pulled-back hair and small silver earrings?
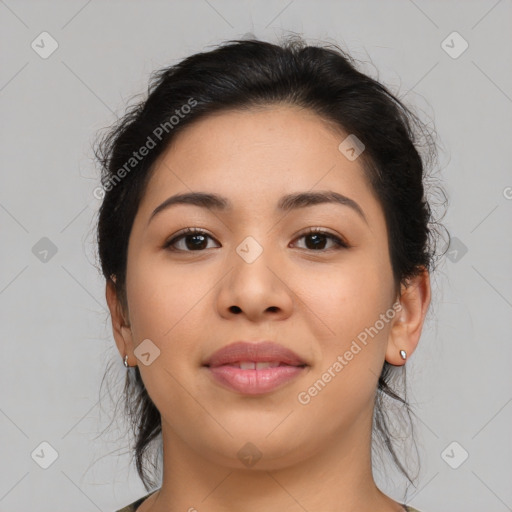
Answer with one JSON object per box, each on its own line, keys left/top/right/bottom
{"left": 98, "top": 39, "right": 444, "bottom": 512}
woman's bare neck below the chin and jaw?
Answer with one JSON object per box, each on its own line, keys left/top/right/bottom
{"left": 144, "top": 408, "right": 403, "bottom": 512}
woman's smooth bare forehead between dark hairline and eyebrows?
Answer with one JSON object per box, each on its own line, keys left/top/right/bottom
{"left": 140, "top": 105, "right": 379, "bottom": 222}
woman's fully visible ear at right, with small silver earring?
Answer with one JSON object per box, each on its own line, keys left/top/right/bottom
{"left": 386, "top": 268, "right": 430, "bottom": 366}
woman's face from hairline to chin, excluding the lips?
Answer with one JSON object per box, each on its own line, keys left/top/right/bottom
{"left": 112, "top": 106, "right": 404, "bottom": 469}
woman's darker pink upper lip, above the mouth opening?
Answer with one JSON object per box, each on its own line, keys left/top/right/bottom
{"left": 204, "top": 341, "right": 306, "bottom": 368}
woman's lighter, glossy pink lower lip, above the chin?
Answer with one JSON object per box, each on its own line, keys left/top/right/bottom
{"left": 207, "top": 365, "right": 305, "bottom": 395}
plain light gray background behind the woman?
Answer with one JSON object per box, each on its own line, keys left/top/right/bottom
{"left": 0, "top": 0, "right": 512, "bottom": 512}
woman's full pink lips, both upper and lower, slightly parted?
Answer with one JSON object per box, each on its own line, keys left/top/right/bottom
{"left": 204, "top": 341, "right": 307, "bottom": 395}
